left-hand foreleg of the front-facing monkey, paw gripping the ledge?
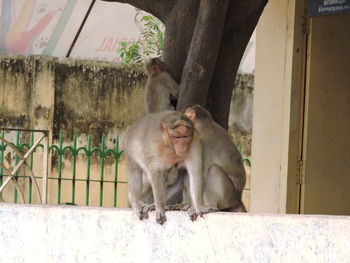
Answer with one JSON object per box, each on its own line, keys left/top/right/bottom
{"left": 149, "top": 171, "right": 166, "bottom": 225}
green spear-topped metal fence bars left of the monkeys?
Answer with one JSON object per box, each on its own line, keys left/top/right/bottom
{"left": 0, "top": 130, "right": 127, "bottom": 207}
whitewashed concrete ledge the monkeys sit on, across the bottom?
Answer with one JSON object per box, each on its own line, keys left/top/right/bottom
{"left": 0, "top": 204, "right": 350, "bottom": 263}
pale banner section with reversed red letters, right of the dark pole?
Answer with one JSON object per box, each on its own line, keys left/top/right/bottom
{"left": 70, "top": 1, "right": 140, "bottom": 62}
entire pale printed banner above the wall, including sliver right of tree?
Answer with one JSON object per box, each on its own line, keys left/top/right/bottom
{"left": 0, "top": 0, "right": 255, "bottom": 73}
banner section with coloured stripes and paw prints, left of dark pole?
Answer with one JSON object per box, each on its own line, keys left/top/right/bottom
{"left": 0, "top": 0, "right": 91, "bottom": 56}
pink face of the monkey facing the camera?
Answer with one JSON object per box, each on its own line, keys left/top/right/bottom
{"left": 169, "top": 126, "right": 193, "bottom": 156}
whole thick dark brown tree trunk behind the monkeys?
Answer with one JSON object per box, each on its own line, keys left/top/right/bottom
{"left": 104, "top": 0, "right": 267, "bottom": 128}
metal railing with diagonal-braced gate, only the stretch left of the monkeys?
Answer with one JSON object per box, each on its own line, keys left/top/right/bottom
{"left": 0, "top": 128, "right": 127, "bottom": 207}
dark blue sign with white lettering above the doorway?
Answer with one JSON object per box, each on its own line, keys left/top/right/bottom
{"left": 308, "top": 0, "right": 350, "bottom": 16}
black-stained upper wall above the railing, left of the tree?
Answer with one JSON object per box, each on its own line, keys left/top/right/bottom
{"left": 0, "top": 56, "right": 145, "bottom": 142}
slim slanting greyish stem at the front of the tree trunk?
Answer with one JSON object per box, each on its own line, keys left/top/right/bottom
{"left": 177, "top": 0, "right": 229, "bottom": 111}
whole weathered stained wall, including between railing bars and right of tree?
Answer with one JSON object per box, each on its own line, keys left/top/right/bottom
{"left": 0, "top": 56, "right": 253, "bottom": 210}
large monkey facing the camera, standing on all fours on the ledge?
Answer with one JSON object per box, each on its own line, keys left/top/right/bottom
{"left": 122, "top": 111, "right": 217, "bottom": 224}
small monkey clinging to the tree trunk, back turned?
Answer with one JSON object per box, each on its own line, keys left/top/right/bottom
{"left": 144, "top": 58, "right": 179, "bottom": 113}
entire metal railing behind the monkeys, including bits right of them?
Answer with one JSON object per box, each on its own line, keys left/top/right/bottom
{"left": 0, "top": 128, "right": 251, "bottom": 207}
